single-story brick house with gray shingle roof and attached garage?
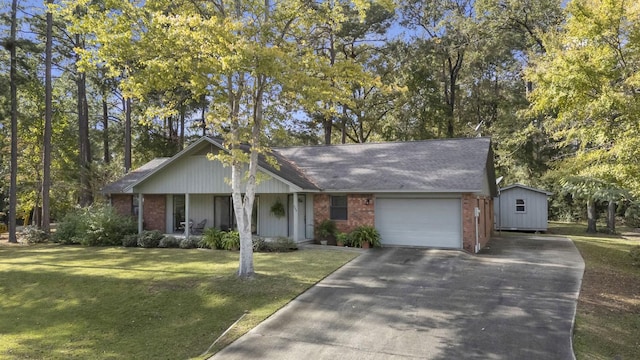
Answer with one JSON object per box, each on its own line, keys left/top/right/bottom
{"left": 103, "top": 137, "right": 497, "bottom": 252}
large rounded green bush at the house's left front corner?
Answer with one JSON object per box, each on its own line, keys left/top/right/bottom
{"left": 54, "top": 205, "right": 137, "bottom": 246}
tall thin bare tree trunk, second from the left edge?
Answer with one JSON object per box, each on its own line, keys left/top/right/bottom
{"left": 41, "top": 0, "right": 53, "bottom": 234}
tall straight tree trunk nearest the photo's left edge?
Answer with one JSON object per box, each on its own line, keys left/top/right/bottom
{"left": 8, "top": 0, "right": 18, "bottom": 243}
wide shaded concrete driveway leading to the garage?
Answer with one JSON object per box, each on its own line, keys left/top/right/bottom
{"left": 213, "top": 236, "right": 584, "bottom": 360}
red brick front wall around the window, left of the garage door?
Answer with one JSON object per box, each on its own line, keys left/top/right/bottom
{"left": 313, "top": 194, "right": 375, "bottom": 238}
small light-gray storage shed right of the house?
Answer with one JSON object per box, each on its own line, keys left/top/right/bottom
{"left": 493, "top": 184, "right": 552, "bottom": 231}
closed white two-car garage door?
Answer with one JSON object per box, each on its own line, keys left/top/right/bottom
{"left": 375, "top": 198, "right": 462, "bottom": 249}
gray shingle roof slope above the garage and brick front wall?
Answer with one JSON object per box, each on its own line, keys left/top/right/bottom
{"left": 274, "top": 138, "right": 493, "bottom": 192}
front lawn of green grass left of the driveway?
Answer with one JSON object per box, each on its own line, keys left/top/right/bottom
{"left": 0, "top": 245, "right": 357, "bottom": 359}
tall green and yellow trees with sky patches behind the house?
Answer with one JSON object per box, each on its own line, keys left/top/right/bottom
{"left": 0, "top": 0, "right": 640, "bottom": 240}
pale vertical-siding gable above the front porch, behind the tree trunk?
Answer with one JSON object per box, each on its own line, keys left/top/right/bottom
{"left": 134, "top": 155, "right": 289, "bottom": 194}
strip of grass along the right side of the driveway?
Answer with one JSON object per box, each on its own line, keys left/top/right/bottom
{"left": 549, "top": 223, "right": 640, "bottom": 360}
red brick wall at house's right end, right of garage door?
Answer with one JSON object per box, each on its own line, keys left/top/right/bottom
{"left": 462, "top": 194, "right": 493, "bottom": 253}
